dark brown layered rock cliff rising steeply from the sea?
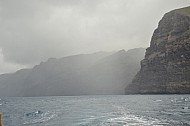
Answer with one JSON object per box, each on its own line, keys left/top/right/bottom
{"left": 126, "top": 7, "right": 190, "bottom": 94}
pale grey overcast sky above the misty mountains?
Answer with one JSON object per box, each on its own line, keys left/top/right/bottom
{"left": 0, "top": 0, "right": 190, "bottom": 73}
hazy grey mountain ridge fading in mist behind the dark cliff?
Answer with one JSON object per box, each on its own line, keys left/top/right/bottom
{"left": 0, "top": 48, "right": 145, "bottom": 96}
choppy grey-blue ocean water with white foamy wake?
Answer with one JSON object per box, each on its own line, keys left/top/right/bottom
{"left": 0, "top": 95, "right": 190, "bottom": 126}
